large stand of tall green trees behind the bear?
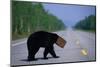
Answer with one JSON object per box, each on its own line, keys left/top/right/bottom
{"left": 12, "top": 1, "right": 65, "bottom": 40}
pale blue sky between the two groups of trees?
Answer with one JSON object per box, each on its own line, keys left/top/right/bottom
{"left": 43, "top": 3, "right": 96, "bottom": 26}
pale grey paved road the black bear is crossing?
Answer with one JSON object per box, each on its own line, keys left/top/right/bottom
{"left": 11, "top": 29, "right": 96, "bottom": 65}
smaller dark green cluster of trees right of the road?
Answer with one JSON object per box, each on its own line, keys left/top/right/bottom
{"left": 74, "top": 15, "right": 96, "bottom": 32}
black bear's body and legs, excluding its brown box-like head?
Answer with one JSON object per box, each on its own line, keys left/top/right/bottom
{"left": 27, "top": 31, "right": 59, "bottom": 61}
